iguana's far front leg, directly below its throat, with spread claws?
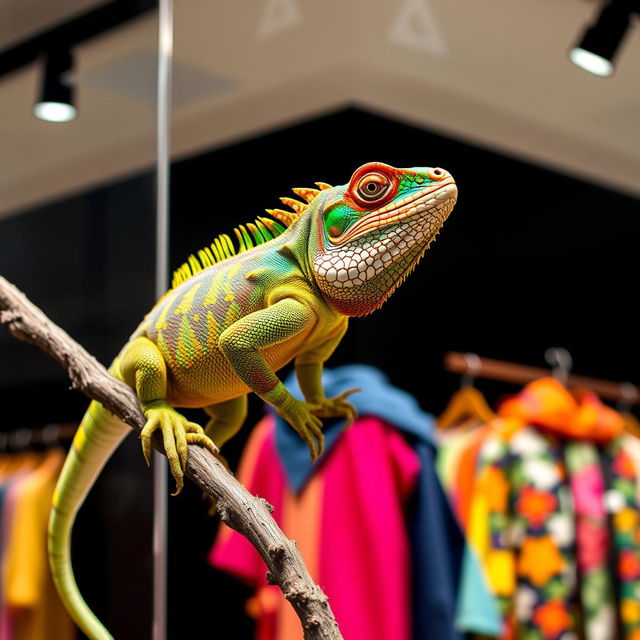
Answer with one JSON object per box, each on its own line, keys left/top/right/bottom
{"left": 296, "top": 318, "right": 360, "bottom": 428}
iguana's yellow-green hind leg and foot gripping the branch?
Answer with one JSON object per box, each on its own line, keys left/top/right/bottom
{"left": 119, "top": 337, "right": 218, "bottom": 495}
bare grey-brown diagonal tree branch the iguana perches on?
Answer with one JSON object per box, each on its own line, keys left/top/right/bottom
{"left": 0, "top": 276, "right": 342, "bottom": 640}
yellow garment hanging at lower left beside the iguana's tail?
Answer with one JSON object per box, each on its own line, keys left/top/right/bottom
{"left": 3, "top": 450, "right": 75, "bottom": 640}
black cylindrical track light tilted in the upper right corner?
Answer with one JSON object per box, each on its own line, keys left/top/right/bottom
{"left": 569, "top": 0, "right": 634, "bottom": 77}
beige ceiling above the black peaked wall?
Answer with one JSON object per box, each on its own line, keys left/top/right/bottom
{"left": 0, "top": 0, "right": 640, "bottom": 215}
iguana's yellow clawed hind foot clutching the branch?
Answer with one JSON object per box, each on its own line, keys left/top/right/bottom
{"left": 140, "top": 403, "right": 219, "bottom": 496}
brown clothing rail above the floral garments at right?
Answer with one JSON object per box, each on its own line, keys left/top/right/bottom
{"left": 444, "top": 351, "right": 640, "bottom": 405}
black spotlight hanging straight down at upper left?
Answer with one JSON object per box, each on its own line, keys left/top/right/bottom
{"left": 33, "top": 49, "right": 78, "bottom": 122}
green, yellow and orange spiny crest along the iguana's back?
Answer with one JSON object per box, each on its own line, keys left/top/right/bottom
{"left": 171, "top": 182, "right": 331, "bottom": 289}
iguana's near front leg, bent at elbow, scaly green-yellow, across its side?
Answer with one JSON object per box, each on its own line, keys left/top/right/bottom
{"left": 219, "top": 298, "right": 324, "bottom": 460}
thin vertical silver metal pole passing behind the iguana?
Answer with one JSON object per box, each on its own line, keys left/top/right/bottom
{"left": 152, "top": 0, "right": 173, "bottom": 640}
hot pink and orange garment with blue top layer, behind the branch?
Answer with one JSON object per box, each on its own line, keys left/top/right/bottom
{"left": 209, "top": 365, "right": 476, "bottom": 640}
